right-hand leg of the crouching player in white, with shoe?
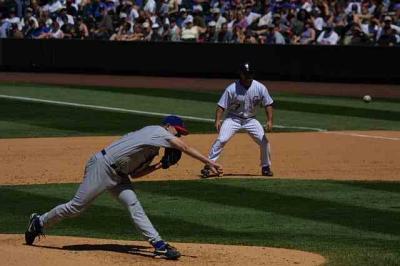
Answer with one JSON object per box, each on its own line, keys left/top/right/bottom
{"left": 243, "top": 119, "right": 273, "bottom": 176}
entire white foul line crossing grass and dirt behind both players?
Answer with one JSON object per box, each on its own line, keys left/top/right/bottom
{"left": 0, "top": 94, "right": 400, "bottom": 141}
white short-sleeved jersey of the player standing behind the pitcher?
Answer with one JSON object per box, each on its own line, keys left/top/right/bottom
{"left": 218, "top": 80, "right": 273, "bottom": 119}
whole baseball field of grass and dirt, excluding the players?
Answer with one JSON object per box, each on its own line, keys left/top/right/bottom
{"left": 0, "top": 74, "right": 400, "bottom": 266}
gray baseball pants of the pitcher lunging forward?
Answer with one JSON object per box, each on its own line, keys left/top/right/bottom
{"left": 40, "top": 153, "right": 161, "bottom": 242}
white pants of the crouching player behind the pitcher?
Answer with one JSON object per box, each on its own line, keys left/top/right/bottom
{"left": 208, "top": 117, "right": 271, "bottom": 167}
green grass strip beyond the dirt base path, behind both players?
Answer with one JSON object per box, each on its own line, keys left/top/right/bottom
{"left": 0, "top": 84, "right": 400, "bottom": 138}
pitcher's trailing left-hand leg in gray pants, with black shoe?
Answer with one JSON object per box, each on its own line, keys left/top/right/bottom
{"left": 25, "top": 156, "right": 116, "bottom": 244}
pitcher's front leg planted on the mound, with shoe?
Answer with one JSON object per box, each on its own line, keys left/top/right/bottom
{"left": 109, "top": 181, "right": 181, "bottom": 259}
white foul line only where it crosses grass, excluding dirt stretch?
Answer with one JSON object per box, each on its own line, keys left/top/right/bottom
{"left": 0, "top": 94, "right": 326, "bottom": 132}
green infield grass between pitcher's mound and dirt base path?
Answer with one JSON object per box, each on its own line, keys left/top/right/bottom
{"left": 0, "top": 179, "right": 400, "bottom": 265}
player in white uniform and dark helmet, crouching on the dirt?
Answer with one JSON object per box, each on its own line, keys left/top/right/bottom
{"left": 201, "top": 63, "right": 273, "bottom": 178}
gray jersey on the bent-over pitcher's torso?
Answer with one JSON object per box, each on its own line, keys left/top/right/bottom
{"left": 105, "top": 126, "right": 176, "bottom": 174}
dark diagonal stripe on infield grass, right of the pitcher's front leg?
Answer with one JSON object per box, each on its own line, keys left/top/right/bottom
{"left": 137, "top": 180, "right": 400, "bottom": 236}
